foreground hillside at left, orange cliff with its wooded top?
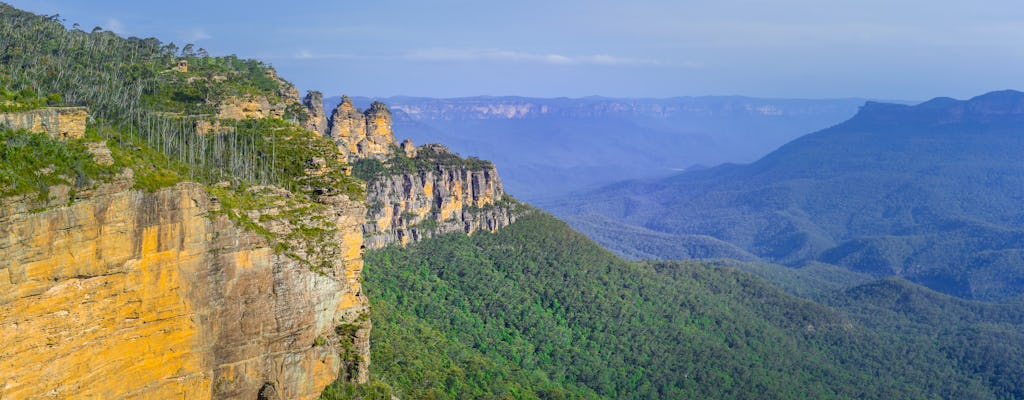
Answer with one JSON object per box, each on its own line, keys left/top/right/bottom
{"left": 0, "top": 4, "right": 370, "bottom": 399}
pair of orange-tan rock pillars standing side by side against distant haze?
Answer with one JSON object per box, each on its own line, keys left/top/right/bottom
{"left": 330, "top": 96, "right": 395, "bottom": 160}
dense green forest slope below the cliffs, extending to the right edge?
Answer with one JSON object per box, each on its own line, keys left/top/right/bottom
{"left": 325, "top": 211, "right": 1024, "bottom": 399}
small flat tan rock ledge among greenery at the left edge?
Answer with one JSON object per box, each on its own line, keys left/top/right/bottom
{"left": 0, "top": 107, "right": 89, "bottom": 139}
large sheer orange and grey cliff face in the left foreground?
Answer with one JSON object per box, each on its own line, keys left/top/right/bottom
{"left": 0, "top": 182, "right": 370, "bottom": 399}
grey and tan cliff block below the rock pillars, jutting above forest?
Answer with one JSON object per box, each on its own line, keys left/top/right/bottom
{"left": 362, "top": 144, "right": 519, "bottom": 249}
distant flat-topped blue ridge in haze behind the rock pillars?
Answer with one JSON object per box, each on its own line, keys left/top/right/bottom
{"left": 324, "top": 96, "right": 864, "bottom": 202}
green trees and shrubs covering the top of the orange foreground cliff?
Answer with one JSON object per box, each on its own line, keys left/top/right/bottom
{"left": 0, "top": 3, "right": 365, "bottom": 276}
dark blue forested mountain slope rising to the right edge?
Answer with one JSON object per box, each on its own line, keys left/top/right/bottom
{"left": 551, "top": 91, "right": 1024, "bottom": 299}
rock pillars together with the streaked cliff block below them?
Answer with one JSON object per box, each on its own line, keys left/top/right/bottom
{"left": 304, "top": 92, "right": 523, "bottom": 249}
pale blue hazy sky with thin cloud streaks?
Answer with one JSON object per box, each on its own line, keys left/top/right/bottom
{"left": 6, "top": 0, "right": 1024, "bottom": 100}
